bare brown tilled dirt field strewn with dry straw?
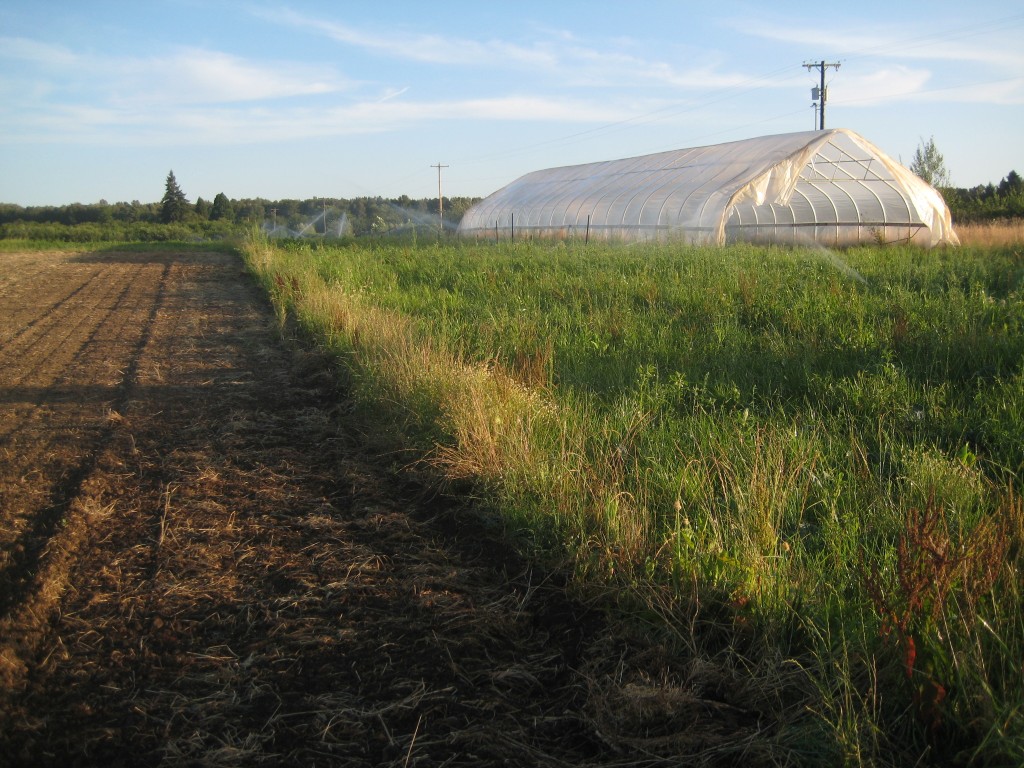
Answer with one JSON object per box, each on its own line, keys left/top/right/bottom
{"left": 0, "top": 252, "right": 765, "bottom": 766}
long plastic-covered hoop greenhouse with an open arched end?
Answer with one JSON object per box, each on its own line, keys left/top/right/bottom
{"left": 459, "top": 128, "right": 957, "bottom": 246}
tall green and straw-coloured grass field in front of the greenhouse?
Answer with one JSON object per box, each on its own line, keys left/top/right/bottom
{"left": 248, "top": 240, "right": 1024, "bottom": 765}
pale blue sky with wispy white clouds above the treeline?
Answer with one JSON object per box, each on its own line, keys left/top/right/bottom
{"left": 0, "top": 0, "right": 1024, "bottom": 206}
